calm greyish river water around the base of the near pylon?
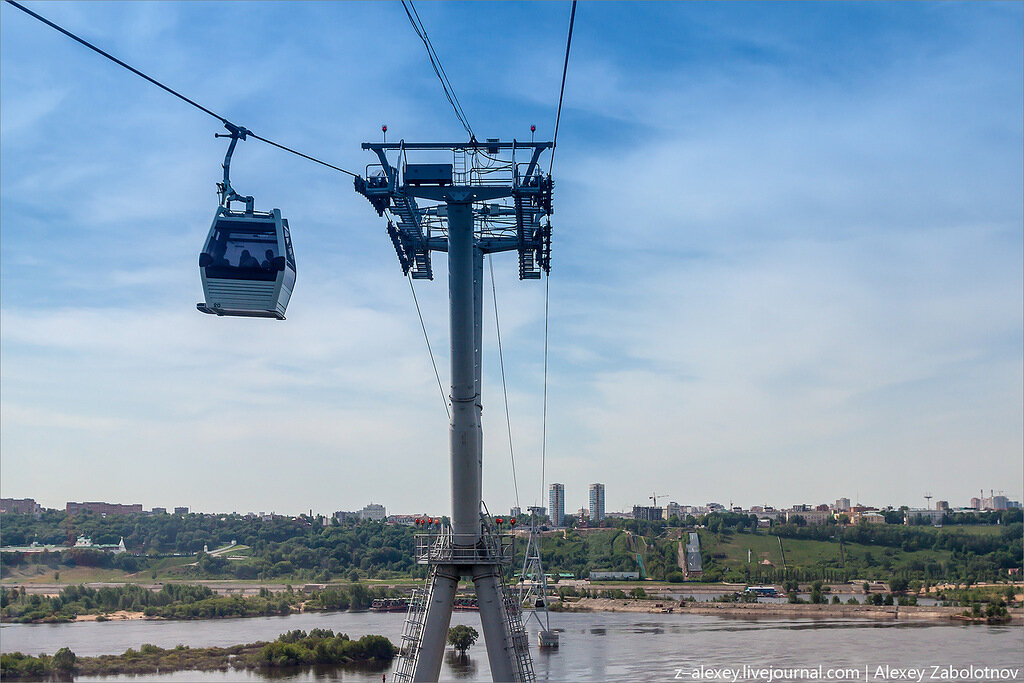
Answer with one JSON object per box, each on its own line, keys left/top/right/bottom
{"left": 0, "top": 612, "right": 1024, "bottom": 683}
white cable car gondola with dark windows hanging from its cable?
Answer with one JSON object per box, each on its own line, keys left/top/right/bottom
{"left": 196, "top": 124, "right": 295, "bottom": 321}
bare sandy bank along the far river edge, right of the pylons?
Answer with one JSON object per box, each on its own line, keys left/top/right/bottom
{"left": 560, "top": 598, "right": 1024, "bottom": 624}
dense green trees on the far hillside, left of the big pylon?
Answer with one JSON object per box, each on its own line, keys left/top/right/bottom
{"left": 0, "top": 512, "right": 415, "bottom": 583}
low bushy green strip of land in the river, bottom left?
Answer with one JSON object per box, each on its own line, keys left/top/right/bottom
{"left": 0, "top": 629, "right": 398, "bottom": 680}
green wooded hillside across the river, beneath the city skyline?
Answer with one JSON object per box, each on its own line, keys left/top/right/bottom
{"left": 0, "top": 510, "right": 1024, "bottom": 583}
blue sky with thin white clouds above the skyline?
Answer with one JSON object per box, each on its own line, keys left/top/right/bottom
{"left": 0, "top": 2, "right": 1024, "bottom": 514}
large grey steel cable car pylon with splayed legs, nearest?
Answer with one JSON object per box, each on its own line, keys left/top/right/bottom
{"left": 354, "top": 139, "right": 552, "bottom": 681}
